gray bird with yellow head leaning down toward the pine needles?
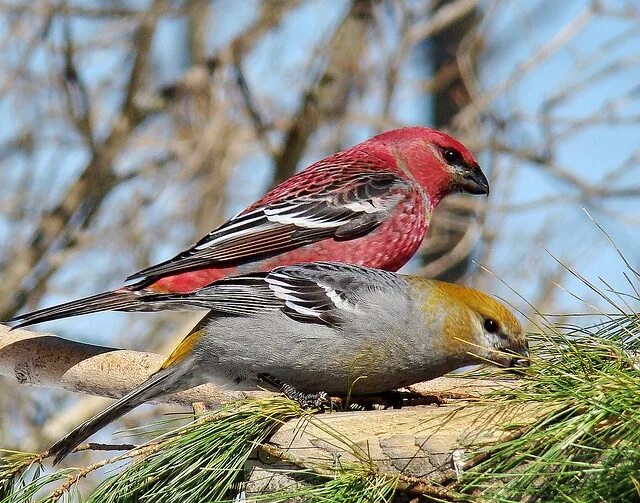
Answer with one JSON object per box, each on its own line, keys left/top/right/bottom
{"left": 50, "top": 262, "right": 528, "bottom": 462}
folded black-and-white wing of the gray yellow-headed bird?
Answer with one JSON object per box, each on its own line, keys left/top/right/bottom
{"left": 152, "top": 262, "right": 402, "bottom": 326}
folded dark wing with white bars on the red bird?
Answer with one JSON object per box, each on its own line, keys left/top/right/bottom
{"left": 127, "top": 172, "right": 413, "bottom": 284}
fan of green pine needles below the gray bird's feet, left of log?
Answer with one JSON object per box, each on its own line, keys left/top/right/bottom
{"left": 88, "top": 399, "right": 302, "bottom": 503}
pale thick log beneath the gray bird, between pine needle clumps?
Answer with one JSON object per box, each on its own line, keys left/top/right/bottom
{"left": 246, "top": 384, "right": 549, "bottom": 494}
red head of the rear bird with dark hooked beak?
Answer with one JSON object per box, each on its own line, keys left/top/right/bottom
{"left": 369, "top": 126, "right": 489, "bottom": 206}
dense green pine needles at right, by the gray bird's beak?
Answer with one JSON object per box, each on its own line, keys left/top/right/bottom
{"left": 458, "top": 314, "right": 640, "bottom": 503}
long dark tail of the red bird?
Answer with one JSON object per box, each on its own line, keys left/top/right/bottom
{"left": 9, "top": 288, "right": 145, "bottom": 329}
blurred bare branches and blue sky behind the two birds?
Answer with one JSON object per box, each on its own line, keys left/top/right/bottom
{"left": 0, "top": 0, "right": 640, "bottom": 466}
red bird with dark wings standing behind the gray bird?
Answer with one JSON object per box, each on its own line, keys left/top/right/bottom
{"left": 10, "top": 127, "right": 489, "bottom": 328}
